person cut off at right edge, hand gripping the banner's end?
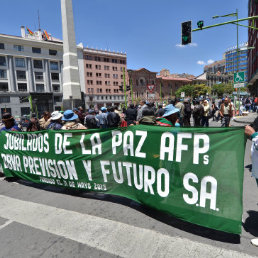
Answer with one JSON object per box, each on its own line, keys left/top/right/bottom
{"left": 245, "top": 125, "right": 258, "bottom": 247}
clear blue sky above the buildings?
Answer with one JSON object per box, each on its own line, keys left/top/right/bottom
{"left": 0, "top": 0, "right": 248, "bottom": 75}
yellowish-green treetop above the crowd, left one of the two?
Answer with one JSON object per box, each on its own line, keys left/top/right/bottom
{"left": 176, "top": 84, "right": 211, "bottom": 98}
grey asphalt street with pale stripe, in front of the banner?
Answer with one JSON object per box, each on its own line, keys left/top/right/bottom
{"left": 0, "top": 116, "right": 258, "bottom": 258}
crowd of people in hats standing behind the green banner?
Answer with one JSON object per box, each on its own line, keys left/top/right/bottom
{"left": 0, "top": 97, "right": 258, "bottom": 132}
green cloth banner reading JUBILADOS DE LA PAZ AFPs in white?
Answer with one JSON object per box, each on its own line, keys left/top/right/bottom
{"left": 0, "top": 125, "right": 245, "bottom": 234}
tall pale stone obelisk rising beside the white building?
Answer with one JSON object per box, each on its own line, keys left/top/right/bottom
{"left": 61, "top": 0, "right": 81, "bottom": 110}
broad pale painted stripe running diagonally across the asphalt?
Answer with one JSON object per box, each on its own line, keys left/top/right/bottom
{"left": 0, "top": 195, "right": 254, "bottom": 258}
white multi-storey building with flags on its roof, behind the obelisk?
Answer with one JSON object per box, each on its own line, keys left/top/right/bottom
{"left": 0, "top": 26, "right": 85, "bottom": 116}
